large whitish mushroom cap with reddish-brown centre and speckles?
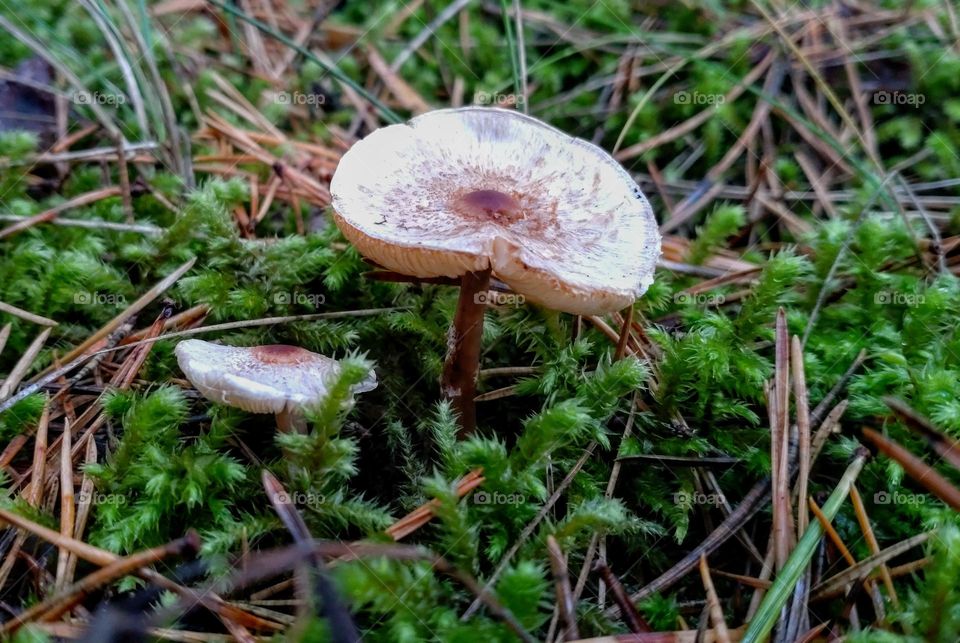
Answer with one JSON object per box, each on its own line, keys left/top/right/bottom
{"left": 330, "top": 107, "right": 660, "bottom": 314}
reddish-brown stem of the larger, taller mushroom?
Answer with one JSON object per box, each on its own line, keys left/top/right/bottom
{"left": 440, "top": 268, "right": 490, "bottom": 437}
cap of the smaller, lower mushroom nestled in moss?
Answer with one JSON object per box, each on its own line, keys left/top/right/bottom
{"left": 174, "top": 339, "right": 377, "bottom": 413}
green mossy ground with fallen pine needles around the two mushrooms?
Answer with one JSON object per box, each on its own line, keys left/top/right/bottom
{"left": 0, "top": 0, "right": 960, "bottom": 641}
